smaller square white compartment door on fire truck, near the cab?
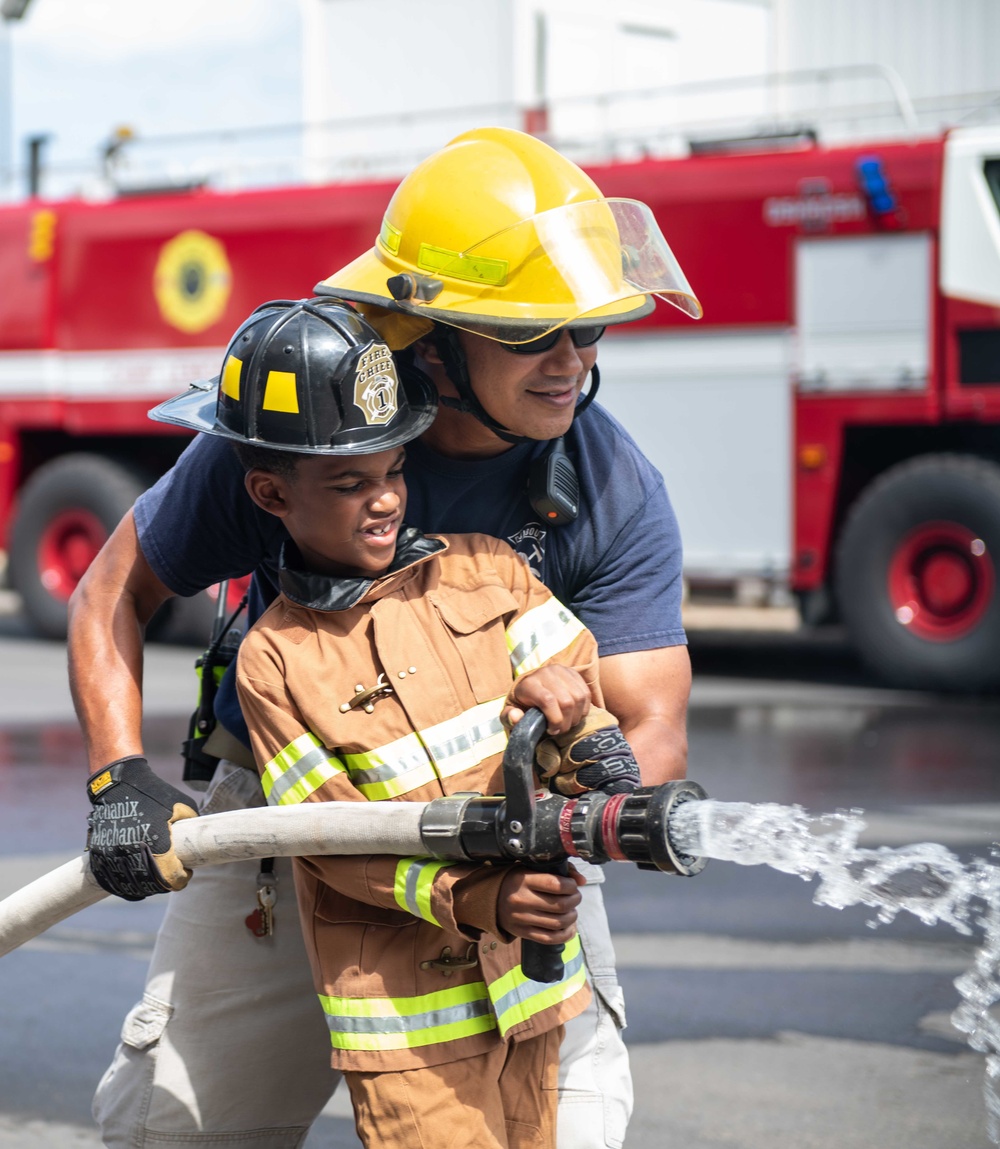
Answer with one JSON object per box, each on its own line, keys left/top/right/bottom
{"left": 795, "top": 232, "right": 932, "bottom": 391}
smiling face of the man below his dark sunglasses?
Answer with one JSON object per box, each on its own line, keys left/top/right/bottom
{"left": 459, "top": 331, "right": 598, "bottom": 439}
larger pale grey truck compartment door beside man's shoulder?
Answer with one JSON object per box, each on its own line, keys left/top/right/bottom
{"left": 584, "top": 327, "right": 792, "bottom": 583}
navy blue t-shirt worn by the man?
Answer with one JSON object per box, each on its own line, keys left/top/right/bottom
{"left": 134, "top": 403, "right": 686, "bottom": 742}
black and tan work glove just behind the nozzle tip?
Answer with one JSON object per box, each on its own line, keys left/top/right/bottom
{"left": 536, "top": 718, "right": 643, "bottom": 797}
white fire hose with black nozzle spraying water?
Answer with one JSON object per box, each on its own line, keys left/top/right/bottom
{"left": 0, "top": 710, "right": 707, "bottom": 981}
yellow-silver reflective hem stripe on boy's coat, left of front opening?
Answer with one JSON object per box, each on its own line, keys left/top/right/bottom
{"left": 320, "top": 981, "right": 497, "bottom": 1050}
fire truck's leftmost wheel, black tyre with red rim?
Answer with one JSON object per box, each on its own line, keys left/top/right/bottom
{"left": 8, "top": 454, "right": 148, "bottom": 639}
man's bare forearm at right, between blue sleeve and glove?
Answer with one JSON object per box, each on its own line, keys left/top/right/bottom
{"left": 599, "top": 646, "right": 691, "bottom": 786}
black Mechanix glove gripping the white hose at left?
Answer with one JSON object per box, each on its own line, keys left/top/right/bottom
{"left": 87, "top": 756, "right": 197, "bottom": 902}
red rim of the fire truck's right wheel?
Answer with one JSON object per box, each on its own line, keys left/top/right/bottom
{"left": 889, "top": 523, "right": 995, "bottom": 642}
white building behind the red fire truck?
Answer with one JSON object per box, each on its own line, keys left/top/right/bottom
{"left": 300, "top": 0, "right": 1000, "bottom": 179}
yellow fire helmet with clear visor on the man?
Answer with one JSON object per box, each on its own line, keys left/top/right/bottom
{"left": 316, "top": 128, "right": 701, "bottom": 347}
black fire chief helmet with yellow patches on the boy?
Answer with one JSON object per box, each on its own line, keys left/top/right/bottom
{"left": 149, "top": 299, "right": 437, "bottom": 455}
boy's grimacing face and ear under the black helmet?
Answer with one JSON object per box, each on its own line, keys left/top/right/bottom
{"left": 246, "top": 447, "right": 406, "bottom": 577}
